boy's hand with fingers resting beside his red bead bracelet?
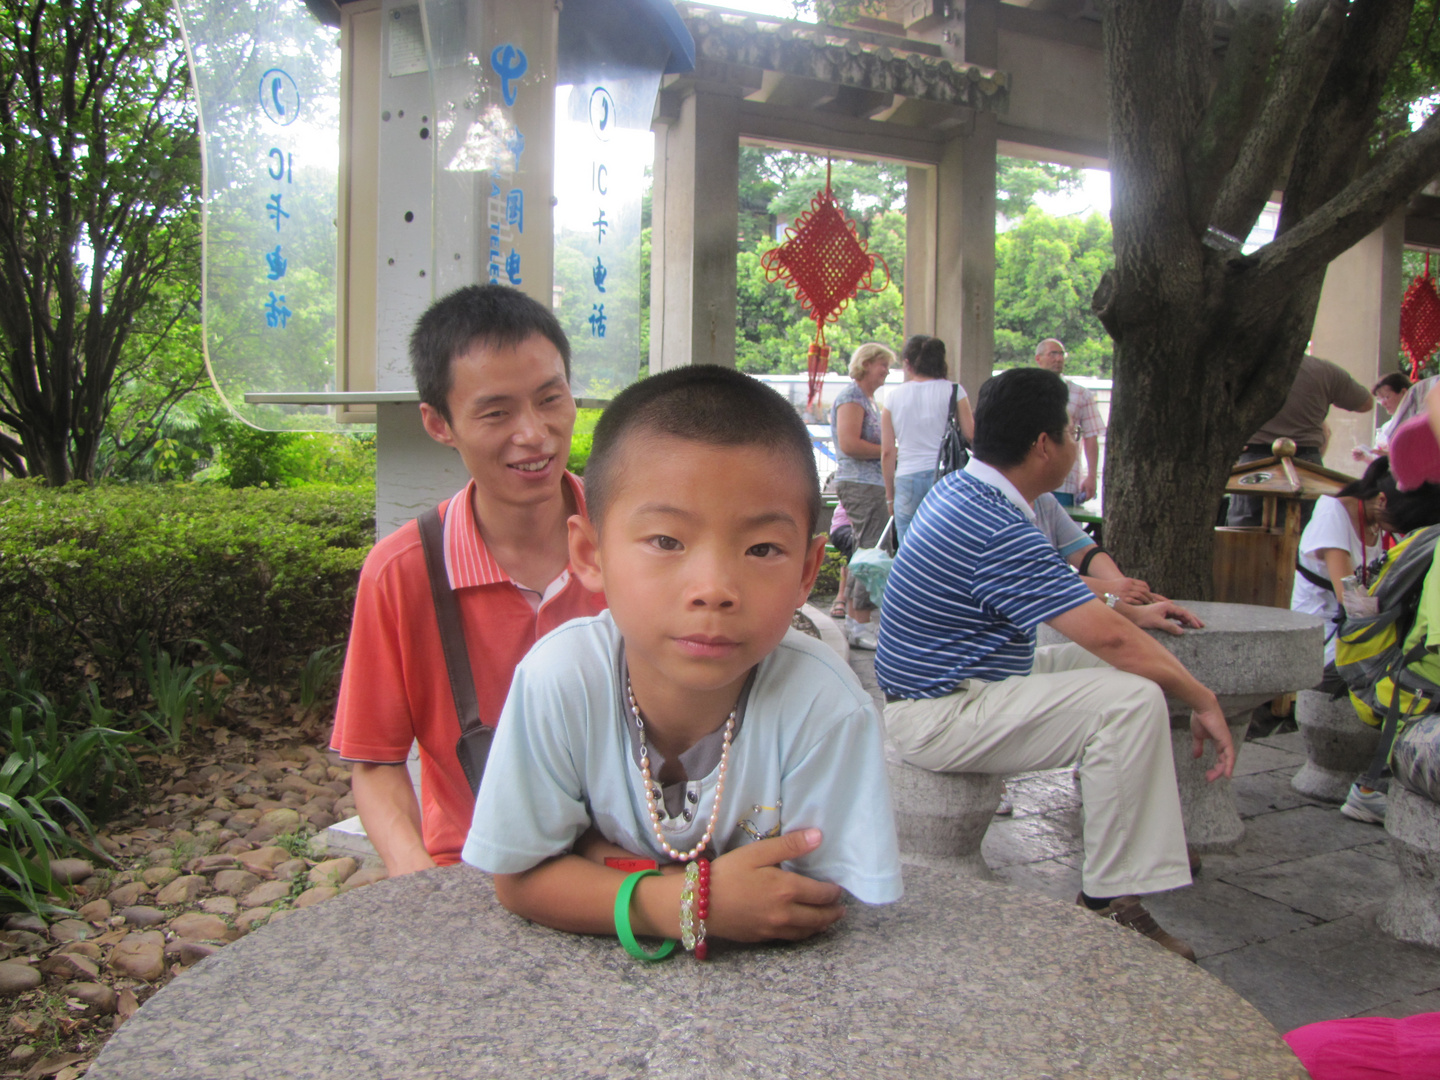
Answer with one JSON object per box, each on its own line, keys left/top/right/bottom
{"left": 706, "top": 829, "right": 845, "bottom": 942}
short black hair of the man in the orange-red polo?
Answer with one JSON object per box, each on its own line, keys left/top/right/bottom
{"left": 410, "top": 285, "right": 570, "bottom": 422}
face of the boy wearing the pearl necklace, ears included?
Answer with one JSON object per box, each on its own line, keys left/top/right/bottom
{"left": 570, "top": 432, "right": 825, "bottom": 708}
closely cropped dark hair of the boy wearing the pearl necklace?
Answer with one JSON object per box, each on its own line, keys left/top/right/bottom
{"left": 585, "top": 364, "right": 819, "bottom": 536}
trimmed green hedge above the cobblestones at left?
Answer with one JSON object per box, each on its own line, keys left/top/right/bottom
{"left": 0, "top": 481, "right": 374, "bottom": 691}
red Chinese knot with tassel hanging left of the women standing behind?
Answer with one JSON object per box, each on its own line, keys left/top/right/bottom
{"left": 760, "top": 164, "right": 890, "bottom": 405}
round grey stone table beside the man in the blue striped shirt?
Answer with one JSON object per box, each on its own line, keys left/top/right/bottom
{"left": 1038, "top": 600, "right": 1325, "bottom": 852}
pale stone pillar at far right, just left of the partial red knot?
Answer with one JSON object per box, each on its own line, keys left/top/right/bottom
{"left": 1310, "top": 212, "right": 1405, "bottom": 474}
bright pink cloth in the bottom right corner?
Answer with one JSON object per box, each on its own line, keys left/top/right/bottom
{"left": 1284, "top": 1012, "right": 1440, "bottom": 1080}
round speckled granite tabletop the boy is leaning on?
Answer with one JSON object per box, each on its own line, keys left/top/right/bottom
{"left": 88, "top": 867, "right": 1305, "bottom": 1080}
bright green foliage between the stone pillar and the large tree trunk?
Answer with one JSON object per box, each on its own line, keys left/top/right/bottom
{"left": 995, "top": 206, "right": 1115, "bottom": 376}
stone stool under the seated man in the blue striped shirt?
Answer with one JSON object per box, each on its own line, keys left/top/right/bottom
{"left": 886, "top": 739, "right": 1002, "bottom": 881}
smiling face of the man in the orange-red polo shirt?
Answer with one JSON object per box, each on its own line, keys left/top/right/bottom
{"left": 420, "top": 334, "right": 575, "bottom": 505}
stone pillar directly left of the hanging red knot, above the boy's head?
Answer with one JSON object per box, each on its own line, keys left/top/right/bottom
{"left": 649, "top": 86, "right": 740, "bottom": 372}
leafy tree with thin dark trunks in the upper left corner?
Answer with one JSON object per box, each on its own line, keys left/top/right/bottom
{"left": 0, "top": 0, "right": 200, "bottom": 484}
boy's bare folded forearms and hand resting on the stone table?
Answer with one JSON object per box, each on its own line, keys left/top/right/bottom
{"left": 495, "top": 829, "right": 845, "bottom": 942}
